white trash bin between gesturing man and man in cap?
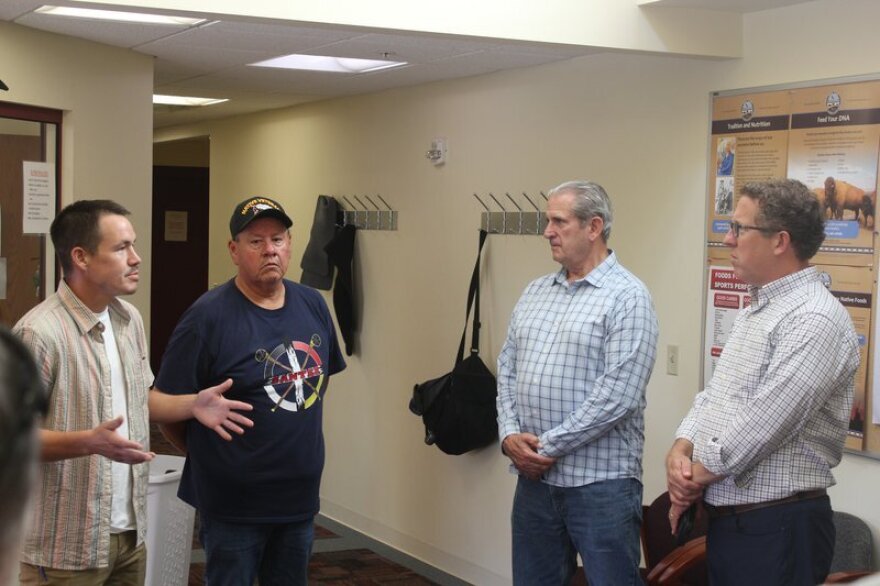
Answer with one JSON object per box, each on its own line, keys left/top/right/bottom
{"left": 146, "top": 455, "right": 195, "bottom": 586}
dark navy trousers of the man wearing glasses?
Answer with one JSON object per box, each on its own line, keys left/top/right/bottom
{"left": 706, "top": 496, "right": 834, "bottom": 586}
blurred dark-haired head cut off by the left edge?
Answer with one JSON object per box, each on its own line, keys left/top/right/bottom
{"left": 0, "top": 326, "right": 47, "bottom": 564}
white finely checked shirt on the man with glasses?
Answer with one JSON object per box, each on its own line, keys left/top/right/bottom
{"left": 676, "top": 267, "right": 859, "bottom": 506}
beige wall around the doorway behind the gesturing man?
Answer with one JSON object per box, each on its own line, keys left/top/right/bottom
{"left": 0, "top": 22, "right": 153, "bottom": 324}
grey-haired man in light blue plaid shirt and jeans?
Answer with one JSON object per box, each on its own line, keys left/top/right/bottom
{"left": 498, "top": 181, "right": 657, "bottom": 586}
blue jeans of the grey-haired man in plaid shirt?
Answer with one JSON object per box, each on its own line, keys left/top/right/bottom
{"left": 511, "top": 476, "right": 642, "bottom": 586}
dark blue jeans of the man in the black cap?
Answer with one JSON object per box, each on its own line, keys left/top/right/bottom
{"left": 199, "top": 516, "right": 315, "bottom": 586}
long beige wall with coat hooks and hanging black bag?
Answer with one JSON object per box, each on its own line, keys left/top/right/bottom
{"left": 157, "top": 0, "right": 880, "bottom": 585}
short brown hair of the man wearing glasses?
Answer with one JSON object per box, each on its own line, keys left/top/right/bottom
{"left": 740, "top": 179, "right": 825, "bottom": 261}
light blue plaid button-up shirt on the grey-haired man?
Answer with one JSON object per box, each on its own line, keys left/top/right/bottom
{"left": 498, "top": 252, "right": 657, "bottom": 487}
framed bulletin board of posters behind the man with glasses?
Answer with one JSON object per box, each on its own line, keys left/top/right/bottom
{"left": 703, "top": 78, "right": 880, "bottom": 459}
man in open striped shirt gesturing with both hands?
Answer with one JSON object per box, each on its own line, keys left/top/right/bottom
{"left": 14, "top": 200, "right": 250, "bottom": 585}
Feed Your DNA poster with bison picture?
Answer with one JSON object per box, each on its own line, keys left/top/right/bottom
{"left": 788, "top": 82, "right": 880, "bottom": 266}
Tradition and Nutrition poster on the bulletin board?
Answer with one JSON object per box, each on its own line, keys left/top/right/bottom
{"left": 707, "top": 92, "right": 791, "bottom": 247}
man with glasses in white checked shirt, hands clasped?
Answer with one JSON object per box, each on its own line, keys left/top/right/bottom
{"left": 666, "top": 180, "right": 859, "bottom": 585}
